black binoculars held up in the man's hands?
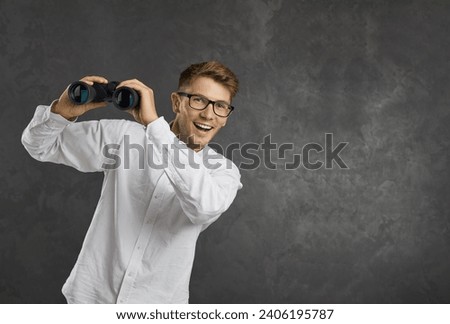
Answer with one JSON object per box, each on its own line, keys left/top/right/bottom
{"left": 68, "top": 81, "right": 139, "bottom": 110}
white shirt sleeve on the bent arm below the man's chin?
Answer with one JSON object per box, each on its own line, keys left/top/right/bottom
{"left": 146, "top": 117, "right": 242, "bottom": 226}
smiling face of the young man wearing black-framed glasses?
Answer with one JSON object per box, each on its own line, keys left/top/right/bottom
{"left": 171, "top": 77, "right": 231, "bottom": 151}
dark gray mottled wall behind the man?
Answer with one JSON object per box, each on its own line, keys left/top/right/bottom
{"left": 0, "top": 0, "right": 450, "bottom": 303}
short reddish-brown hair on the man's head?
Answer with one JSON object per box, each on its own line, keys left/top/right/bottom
{"left": 178, "top": 61, "right": 239, "bottom": 97}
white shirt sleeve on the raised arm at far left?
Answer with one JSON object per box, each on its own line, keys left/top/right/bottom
{"left": 22, "top": 105, "right": 125, "bottom": 172}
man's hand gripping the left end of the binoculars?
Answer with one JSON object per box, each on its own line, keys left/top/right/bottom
{"left": 51, "top": 76, "right": 108, "bottom": 120}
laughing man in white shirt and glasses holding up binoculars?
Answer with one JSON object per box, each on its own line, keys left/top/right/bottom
{"left": 22, "top": 61, "right": 242, "bottom": 303}
